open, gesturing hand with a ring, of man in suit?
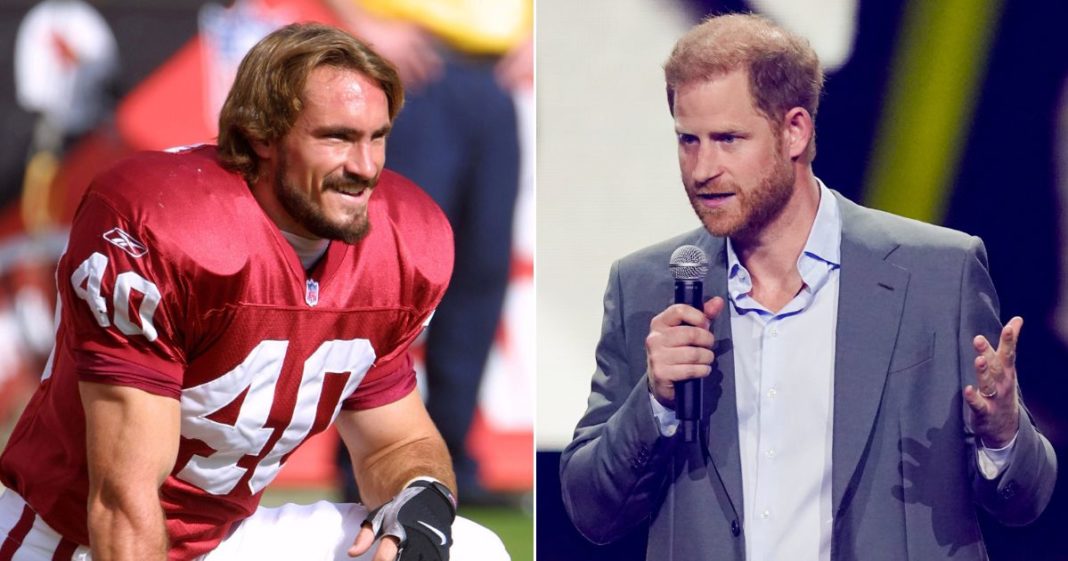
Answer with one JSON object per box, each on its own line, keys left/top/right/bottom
{"left": 964, "top": 316, "right": 1023, "bottom": 448}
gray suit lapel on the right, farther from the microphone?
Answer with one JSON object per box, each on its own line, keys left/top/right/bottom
{"left": 831, "top": 193, "right": 909, "bottom": 514}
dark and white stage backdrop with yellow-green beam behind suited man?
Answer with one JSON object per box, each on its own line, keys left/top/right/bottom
{"left": 536, "top": 0, "right": 1068, "bottom": 561}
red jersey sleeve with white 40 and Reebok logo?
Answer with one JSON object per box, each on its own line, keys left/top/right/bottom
{"left": 57, "top": 188, "right": 186, "bottom": 399}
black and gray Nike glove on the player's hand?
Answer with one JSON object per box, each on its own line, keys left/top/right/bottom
{"left": 364, "top": 480, "right": 456, "bottom": 561}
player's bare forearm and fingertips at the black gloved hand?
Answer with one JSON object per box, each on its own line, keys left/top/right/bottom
{"left": 336, "top": 391, "right": 456, "bottom": 561}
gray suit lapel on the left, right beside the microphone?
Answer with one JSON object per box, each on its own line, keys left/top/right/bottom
{"left": 700, "top": 233, "right": 742, "bottom": 518}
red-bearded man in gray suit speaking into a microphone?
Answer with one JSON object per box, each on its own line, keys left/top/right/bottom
{"left": 561, "top": 15, "right": 1056, "bottom": 561}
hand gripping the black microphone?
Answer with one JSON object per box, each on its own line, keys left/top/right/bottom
{"left": 645, "top": 296, "right": 724, "bottom": 409}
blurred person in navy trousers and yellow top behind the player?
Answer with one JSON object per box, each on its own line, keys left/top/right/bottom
{"left": 327, "top": 0, "right": 533, "bottom": 504}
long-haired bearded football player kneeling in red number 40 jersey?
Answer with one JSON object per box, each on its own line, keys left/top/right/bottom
{"left": 0, "top": 25, "right": 507, "bottom": 561}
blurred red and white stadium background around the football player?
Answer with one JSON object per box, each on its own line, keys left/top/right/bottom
{"left": 0, "top": 0, "right": 534, "bottom": 561}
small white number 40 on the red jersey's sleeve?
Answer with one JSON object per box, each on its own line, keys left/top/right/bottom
{"left": 70, "top": 252, "right": 160, "bottom": 342}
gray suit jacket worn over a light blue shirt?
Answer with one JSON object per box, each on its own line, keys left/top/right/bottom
{"left": 561, "top": 193, "right": 1056, "bottom": 561}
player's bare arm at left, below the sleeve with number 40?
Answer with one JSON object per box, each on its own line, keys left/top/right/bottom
{"left": 79, "top": 381, "right": 179, "bottom": 561}
